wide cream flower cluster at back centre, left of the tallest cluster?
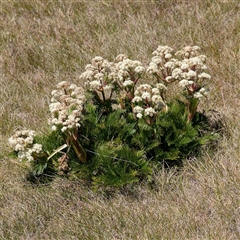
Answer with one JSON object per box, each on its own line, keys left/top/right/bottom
{"left": 80, "top": 54, "right": 145, "bottom": 101}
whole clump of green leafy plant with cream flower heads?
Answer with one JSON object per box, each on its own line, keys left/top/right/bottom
{"left": 9, "top": 46, "right": 218, "bottom": 188}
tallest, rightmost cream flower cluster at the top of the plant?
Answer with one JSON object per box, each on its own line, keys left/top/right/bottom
{"left": 147, "top": 46, "right": 211, "bottom": 99}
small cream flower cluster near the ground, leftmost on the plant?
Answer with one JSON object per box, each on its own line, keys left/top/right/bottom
{"left": 8, "top": 130, "right": 42, "bottom": 161}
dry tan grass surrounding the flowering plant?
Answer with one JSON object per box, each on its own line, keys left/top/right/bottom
{"left": 0, "top": 0, "right": 240, "bottom": 240}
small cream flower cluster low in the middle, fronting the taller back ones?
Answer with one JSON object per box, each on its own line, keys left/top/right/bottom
{"left": 132, "top": 83, "right": 167, "bottom": 118}
